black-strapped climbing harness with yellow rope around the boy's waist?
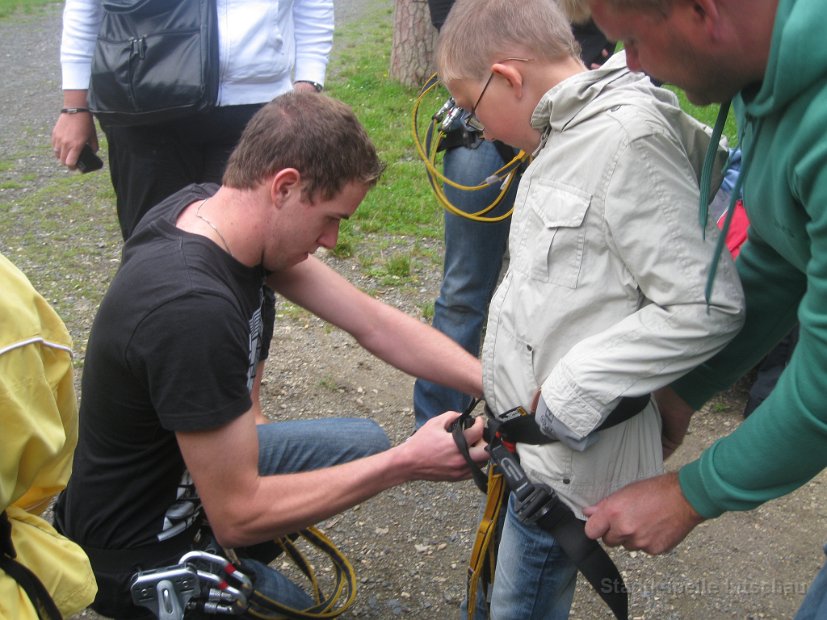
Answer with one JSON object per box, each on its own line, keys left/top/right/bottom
{"left": 451, "top": 394, "right": 650, "bottom": 620}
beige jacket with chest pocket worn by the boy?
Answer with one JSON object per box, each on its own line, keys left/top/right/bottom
{"left": 482, "top": 52, "right": 743, "bottom": 517}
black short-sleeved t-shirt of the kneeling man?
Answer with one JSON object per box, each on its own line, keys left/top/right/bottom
{"left": 56, "top": 185, "right": 264, "bottom": 549}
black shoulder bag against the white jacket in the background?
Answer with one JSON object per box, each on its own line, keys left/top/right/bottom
{"left": 89, "top": 0, "right": 218, "bottom": 125}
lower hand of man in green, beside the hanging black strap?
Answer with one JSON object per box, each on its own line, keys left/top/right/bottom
{"left": 583, "top": 473, "right": 704, "bottom": 555}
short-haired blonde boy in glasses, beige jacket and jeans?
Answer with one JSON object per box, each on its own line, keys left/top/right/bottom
{"left": 437, "top": 0, "right": 743, "bottom": 620}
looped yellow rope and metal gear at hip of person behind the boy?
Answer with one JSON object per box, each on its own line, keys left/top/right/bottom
{"left": 412, "top": 74, "right": 529, "bottom": 222}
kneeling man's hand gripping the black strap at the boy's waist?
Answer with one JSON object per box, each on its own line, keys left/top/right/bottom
{"left": 398, "top": 411, "right": 488, "bottom": 481}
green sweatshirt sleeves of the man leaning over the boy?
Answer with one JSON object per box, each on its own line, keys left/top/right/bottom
{"left": 675, "top": 118, "right": 827, "bottom": 517}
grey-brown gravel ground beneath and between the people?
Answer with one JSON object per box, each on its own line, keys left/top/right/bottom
{"left": 0, "top": 0, "right": 827, "bottom": 620}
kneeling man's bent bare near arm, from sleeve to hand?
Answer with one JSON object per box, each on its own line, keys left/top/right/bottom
{"left": 187, "top": 413, "right": 487, "bottom": 547}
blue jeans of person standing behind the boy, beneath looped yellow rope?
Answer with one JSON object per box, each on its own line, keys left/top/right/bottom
{"left": 413, "top": 141, "right": 517, "bottom": 428}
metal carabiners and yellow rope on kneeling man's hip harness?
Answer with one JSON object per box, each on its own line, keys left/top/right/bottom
{"left": 130, "top": 527, "right": 356, "bottom": 620}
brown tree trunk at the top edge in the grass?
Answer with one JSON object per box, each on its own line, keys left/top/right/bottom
{"left": 389, "top": 0, "right": 437, "bottom": 87}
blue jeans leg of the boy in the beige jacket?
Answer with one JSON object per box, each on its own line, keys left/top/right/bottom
{"left": 490, "top": 493, "right": 577, "bottom": 620}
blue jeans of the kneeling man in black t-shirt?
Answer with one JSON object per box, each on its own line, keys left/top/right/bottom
{"left": 233, "top": 418, "right": 390, "bottom": 609}
